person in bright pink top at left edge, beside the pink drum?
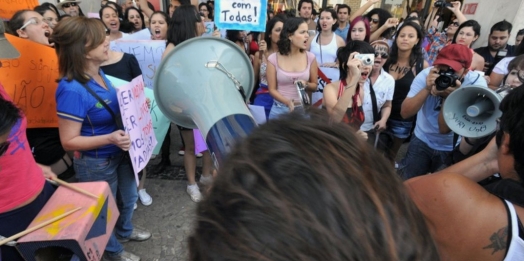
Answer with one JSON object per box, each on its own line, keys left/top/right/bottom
{"left": 0, "top": 89, "right": 56, "bottom": 261}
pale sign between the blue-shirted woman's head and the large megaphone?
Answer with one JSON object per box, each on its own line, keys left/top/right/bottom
{"left": 110, "top": 40, "right": 166, "bottom": 88}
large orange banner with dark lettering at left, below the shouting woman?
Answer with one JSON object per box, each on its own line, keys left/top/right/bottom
{"left": 0, "top": 34, "right": 58, "bottom": 128}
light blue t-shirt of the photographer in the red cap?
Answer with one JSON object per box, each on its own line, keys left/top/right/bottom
{"left": 407, "top": 67, "right": 488, "bottom": 151}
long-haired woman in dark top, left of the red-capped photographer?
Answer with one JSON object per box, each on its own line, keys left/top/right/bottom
{"left": 384, "top": 21, "right": 428, "bottom": 162}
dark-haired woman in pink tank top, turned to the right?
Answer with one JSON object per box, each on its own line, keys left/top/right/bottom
{"left": 267, "top": 17, "right": 318, "bottom": 119}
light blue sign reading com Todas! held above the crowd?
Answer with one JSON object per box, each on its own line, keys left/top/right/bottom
{"left": 215, "top": 0, "right": 267, "bottom": 32}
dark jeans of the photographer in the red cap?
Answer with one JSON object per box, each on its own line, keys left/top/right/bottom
{"left": 397, "top": 134, "right": 451, "bottom": 180}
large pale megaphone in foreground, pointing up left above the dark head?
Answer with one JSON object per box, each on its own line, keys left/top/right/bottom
{"left": 154, "top": 37, "right": 256, "bottom": 167}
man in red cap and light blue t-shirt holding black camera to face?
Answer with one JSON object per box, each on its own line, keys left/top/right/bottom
{"left": 398, "top": 44, "right": 487, "bottom": 180}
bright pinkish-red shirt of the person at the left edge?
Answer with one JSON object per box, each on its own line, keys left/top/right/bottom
{"left": 0, "top": 84, "right": 45, "bottom": 213}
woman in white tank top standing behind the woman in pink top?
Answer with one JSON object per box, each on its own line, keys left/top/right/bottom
{"left": 308, "top": 9, "right": 346, "bottom": 104}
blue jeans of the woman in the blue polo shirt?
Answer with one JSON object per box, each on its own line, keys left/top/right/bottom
{"left": 74, "top": 152, "right": 138, "bottom": 255}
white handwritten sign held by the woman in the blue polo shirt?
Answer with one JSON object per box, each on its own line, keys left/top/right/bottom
{"left": 117, "top": 75, "right": 157, "bottom": 185}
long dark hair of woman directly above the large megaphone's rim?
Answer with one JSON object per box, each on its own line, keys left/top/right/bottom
{"left": 166, "top": 5, "right": 202, "bottom": 46}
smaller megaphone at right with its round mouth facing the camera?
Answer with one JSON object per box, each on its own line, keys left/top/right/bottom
{"left": 443, "top": 85, "right": 511, "bottom": 138}
